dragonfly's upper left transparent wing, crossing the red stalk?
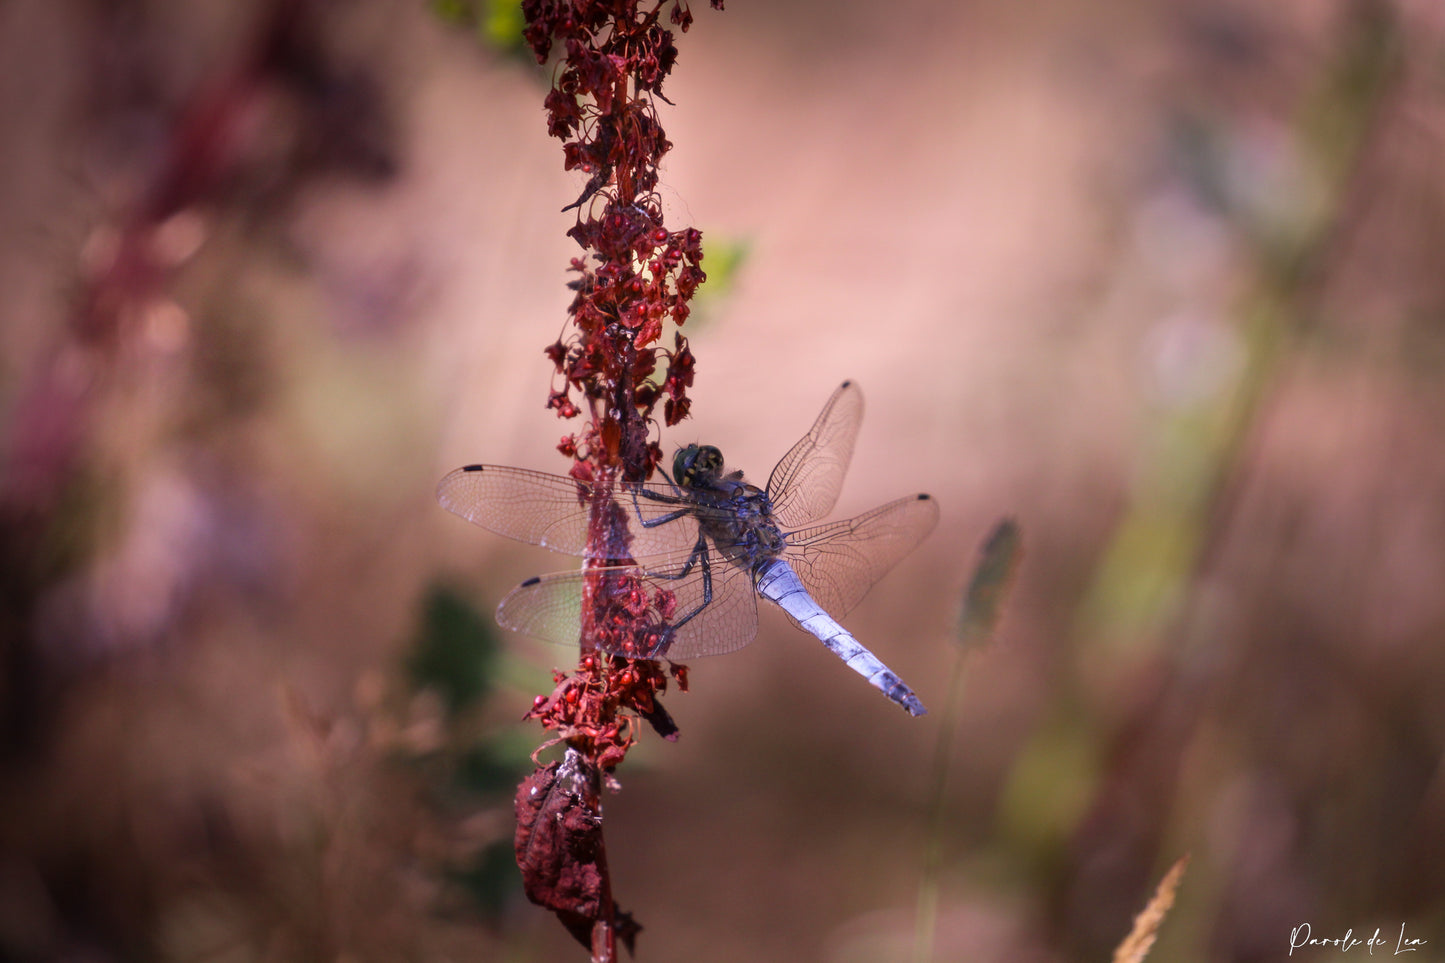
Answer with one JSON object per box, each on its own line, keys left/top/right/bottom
{"left": 436, "top": 464, "right": 698, "bottom": 558}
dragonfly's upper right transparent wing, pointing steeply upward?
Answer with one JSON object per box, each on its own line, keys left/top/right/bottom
{"left": 767, "top": 382, "right": 863, "bottom": 528}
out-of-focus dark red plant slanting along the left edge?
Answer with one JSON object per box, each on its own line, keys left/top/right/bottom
{"left": 0, "top": 0, "right": 397, "bottom": 761}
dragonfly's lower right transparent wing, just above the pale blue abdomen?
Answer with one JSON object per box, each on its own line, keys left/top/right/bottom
{"left": 783, "top": 495, "right": 938, "bottom": 619}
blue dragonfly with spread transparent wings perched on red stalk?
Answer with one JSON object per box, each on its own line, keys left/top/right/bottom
{"left": 436, "top": 382, "right": 938, "bottom": 716}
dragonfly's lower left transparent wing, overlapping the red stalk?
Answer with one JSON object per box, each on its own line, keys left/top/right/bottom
{"left": 497, "top": 552, "right": 757, "bottom": 661}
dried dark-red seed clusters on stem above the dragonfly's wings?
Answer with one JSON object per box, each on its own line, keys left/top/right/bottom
{"left": 523, "top": 0, "right": 723, "bottom": 480}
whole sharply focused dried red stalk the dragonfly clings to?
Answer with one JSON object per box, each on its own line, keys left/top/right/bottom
{"left": 516, "top": 0, "right": 723, "bottom": 960}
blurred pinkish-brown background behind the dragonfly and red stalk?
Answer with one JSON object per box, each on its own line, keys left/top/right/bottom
{"left": 0, "top": 0, "right": 1445, "bottom": 963}
